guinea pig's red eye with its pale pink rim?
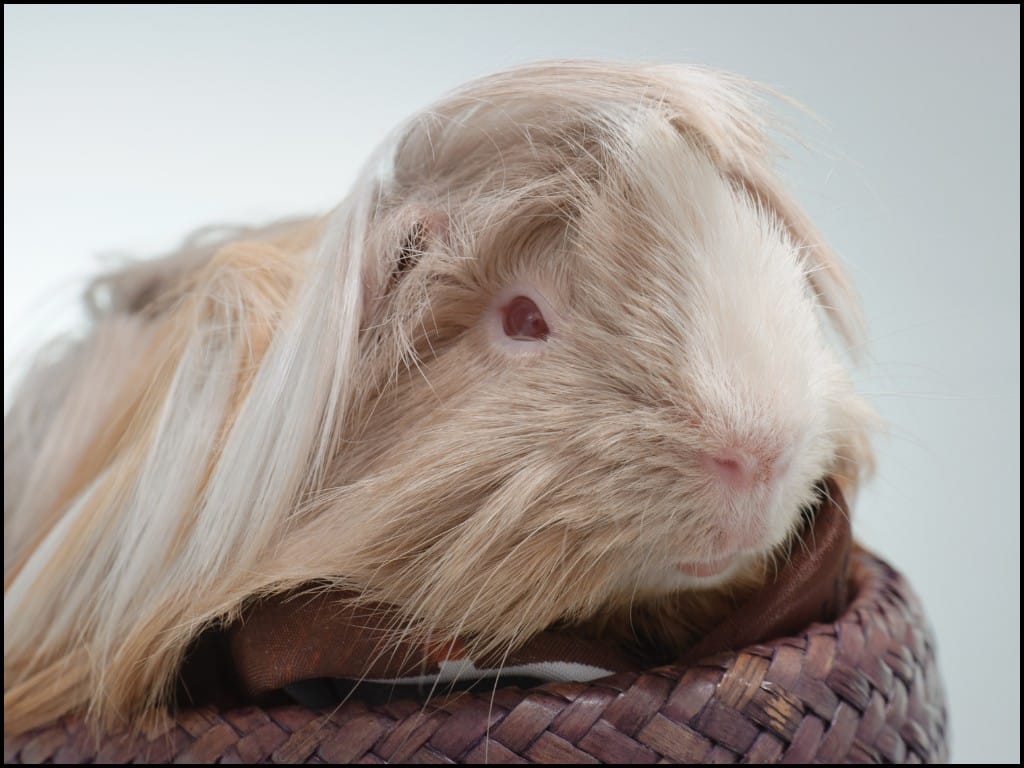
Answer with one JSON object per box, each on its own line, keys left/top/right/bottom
{"left": 482, "top": 283, "right": 565, "bottom": 356}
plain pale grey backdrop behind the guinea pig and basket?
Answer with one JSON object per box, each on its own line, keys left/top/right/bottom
{"left": 4, "top": 6, "right": 1020, "bottom": 763}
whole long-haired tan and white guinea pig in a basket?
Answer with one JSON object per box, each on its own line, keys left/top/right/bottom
{"left": 4, "top": 61, "right": 869, "bottom": 731}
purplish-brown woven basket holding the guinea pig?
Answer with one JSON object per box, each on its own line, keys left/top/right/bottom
{"left": 4, "top": 551, "right": 947, "bottom": 763}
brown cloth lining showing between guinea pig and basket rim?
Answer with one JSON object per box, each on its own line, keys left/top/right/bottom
{"left": 226, "top": 482, "right": 851, "bottom": 700}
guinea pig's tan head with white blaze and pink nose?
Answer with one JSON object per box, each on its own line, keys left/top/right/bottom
{"left": 301, "top": 67, "right": 866, "bottom": 642}
